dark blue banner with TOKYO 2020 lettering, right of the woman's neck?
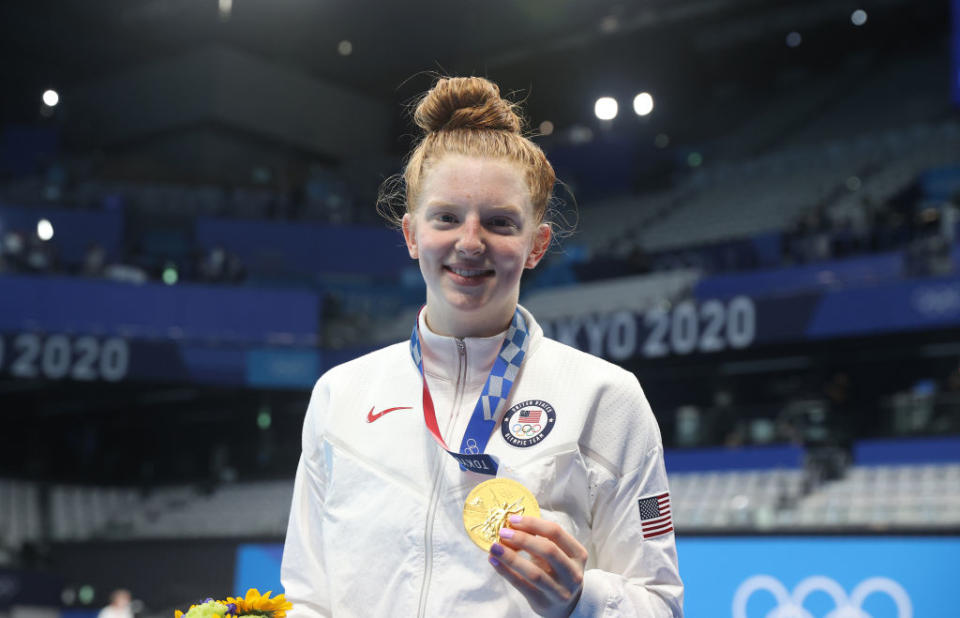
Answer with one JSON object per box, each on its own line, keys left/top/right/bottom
{"left": 541, "top": 277, "right": 960, "bottom": 362}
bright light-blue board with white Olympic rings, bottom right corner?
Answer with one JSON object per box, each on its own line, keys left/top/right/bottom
{"left": 677, "top": 534, "right": 960, "bottom": 618}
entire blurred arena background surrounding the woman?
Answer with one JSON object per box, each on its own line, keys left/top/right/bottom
{"left": 0, "top": 0, "right": 960, "bottom": 618}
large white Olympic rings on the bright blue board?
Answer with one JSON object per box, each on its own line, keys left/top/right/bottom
{"left": 733, "top": 575, "right": 913, "bottom": 618}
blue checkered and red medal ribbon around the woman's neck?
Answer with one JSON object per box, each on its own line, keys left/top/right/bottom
{"left": 410, "top": 309, "right": 530, "bottom": 476}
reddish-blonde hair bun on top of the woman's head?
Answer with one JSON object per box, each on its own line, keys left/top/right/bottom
{"left": 413, "top": 77, "right": 521, "bottom": 133}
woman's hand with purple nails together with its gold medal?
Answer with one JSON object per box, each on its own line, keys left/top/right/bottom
{"left": 463, "top": 478, "right": 587, "bottom": 617}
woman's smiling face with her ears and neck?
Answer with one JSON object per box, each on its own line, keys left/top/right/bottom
{"left": 403, "top": 154, "right": 550, "bottom": 337}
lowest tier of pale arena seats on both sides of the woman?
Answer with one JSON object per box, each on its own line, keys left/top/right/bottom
{"left": 0, "top": 430, "right": 960, "bottom": 550}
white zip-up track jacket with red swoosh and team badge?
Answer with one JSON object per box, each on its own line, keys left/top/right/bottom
{"left": 281, "top": 308, "right": 683, "bottom": 618}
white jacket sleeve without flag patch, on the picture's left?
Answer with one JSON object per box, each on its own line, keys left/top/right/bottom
{"left": 280, "top": 379, "right": 331, "bottom": 618}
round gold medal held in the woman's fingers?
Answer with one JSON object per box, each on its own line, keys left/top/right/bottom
{"left": 463, "top": 478, "right": 540, "bottom": 551}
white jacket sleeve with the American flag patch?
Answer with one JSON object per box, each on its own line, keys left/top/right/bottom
{"left": 572, "top": 381, "right": 683, "bottom": 618}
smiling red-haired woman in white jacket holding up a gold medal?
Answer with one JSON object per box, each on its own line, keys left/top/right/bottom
{"left": 282, "top": 78, "right": 683, "bottom": 618}
